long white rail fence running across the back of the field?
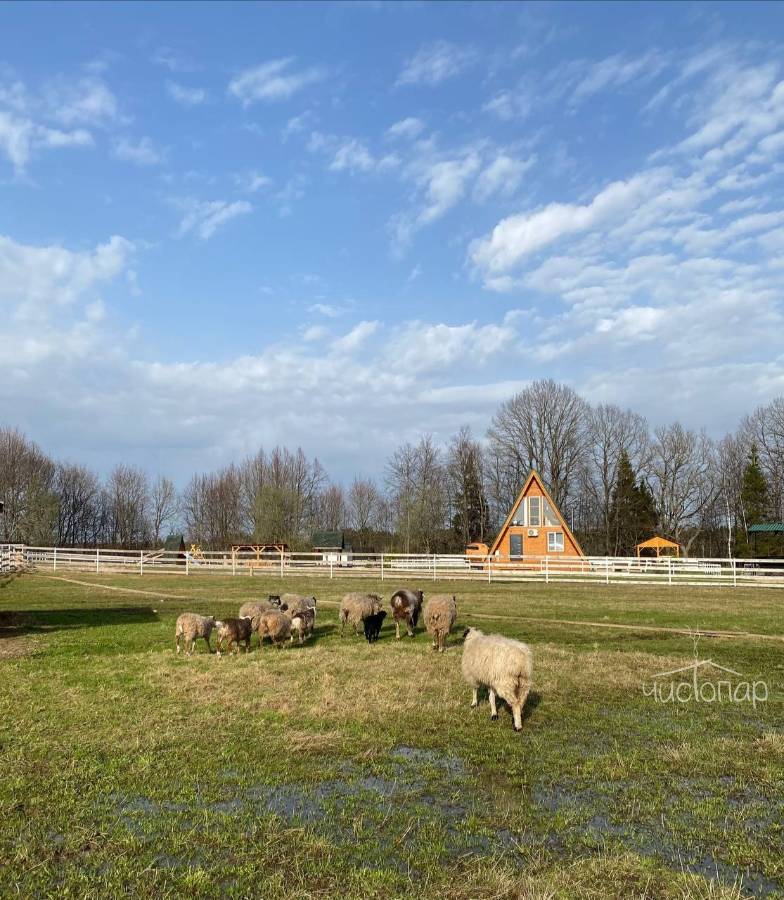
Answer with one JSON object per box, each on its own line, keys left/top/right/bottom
{"left": 6, "top": 545, "right": 784, "bottom": 587}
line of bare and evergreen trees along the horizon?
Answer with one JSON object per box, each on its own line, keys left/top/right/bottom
{"left": 0, "top": 380, "right": 784, "bottom": 556}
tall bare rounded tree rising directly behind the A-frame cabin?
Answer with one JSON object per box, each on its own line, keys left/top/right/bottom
{"left": 488, "top": 379, "right": 588, "bottom": 507}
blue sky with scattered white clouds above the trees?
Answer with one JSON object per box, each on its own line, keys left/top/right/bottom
{"left": 0, "top": 2, "right": 784, "bottom": 484}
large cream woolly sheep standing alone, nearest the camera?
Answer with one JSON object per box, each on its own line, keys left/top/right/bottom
{"left": 460, "top": 628, "right": 533, "bottom": 731}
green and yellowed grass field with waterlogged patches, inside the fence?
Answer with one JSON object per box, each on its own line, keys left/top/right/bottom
{"left": 0, "top": 574, "right": 784, "bottom": 898}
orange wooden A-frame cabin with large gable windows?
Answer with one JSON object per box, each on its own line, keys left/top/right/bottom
{"left": 490, "top": 469, "right": 585, "bottom": 562}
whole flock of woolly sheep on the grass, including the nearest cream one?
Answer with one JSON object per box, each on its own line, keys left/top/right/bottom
{"left": 175, "top": 589, "right": 533, "bottom": 731}
